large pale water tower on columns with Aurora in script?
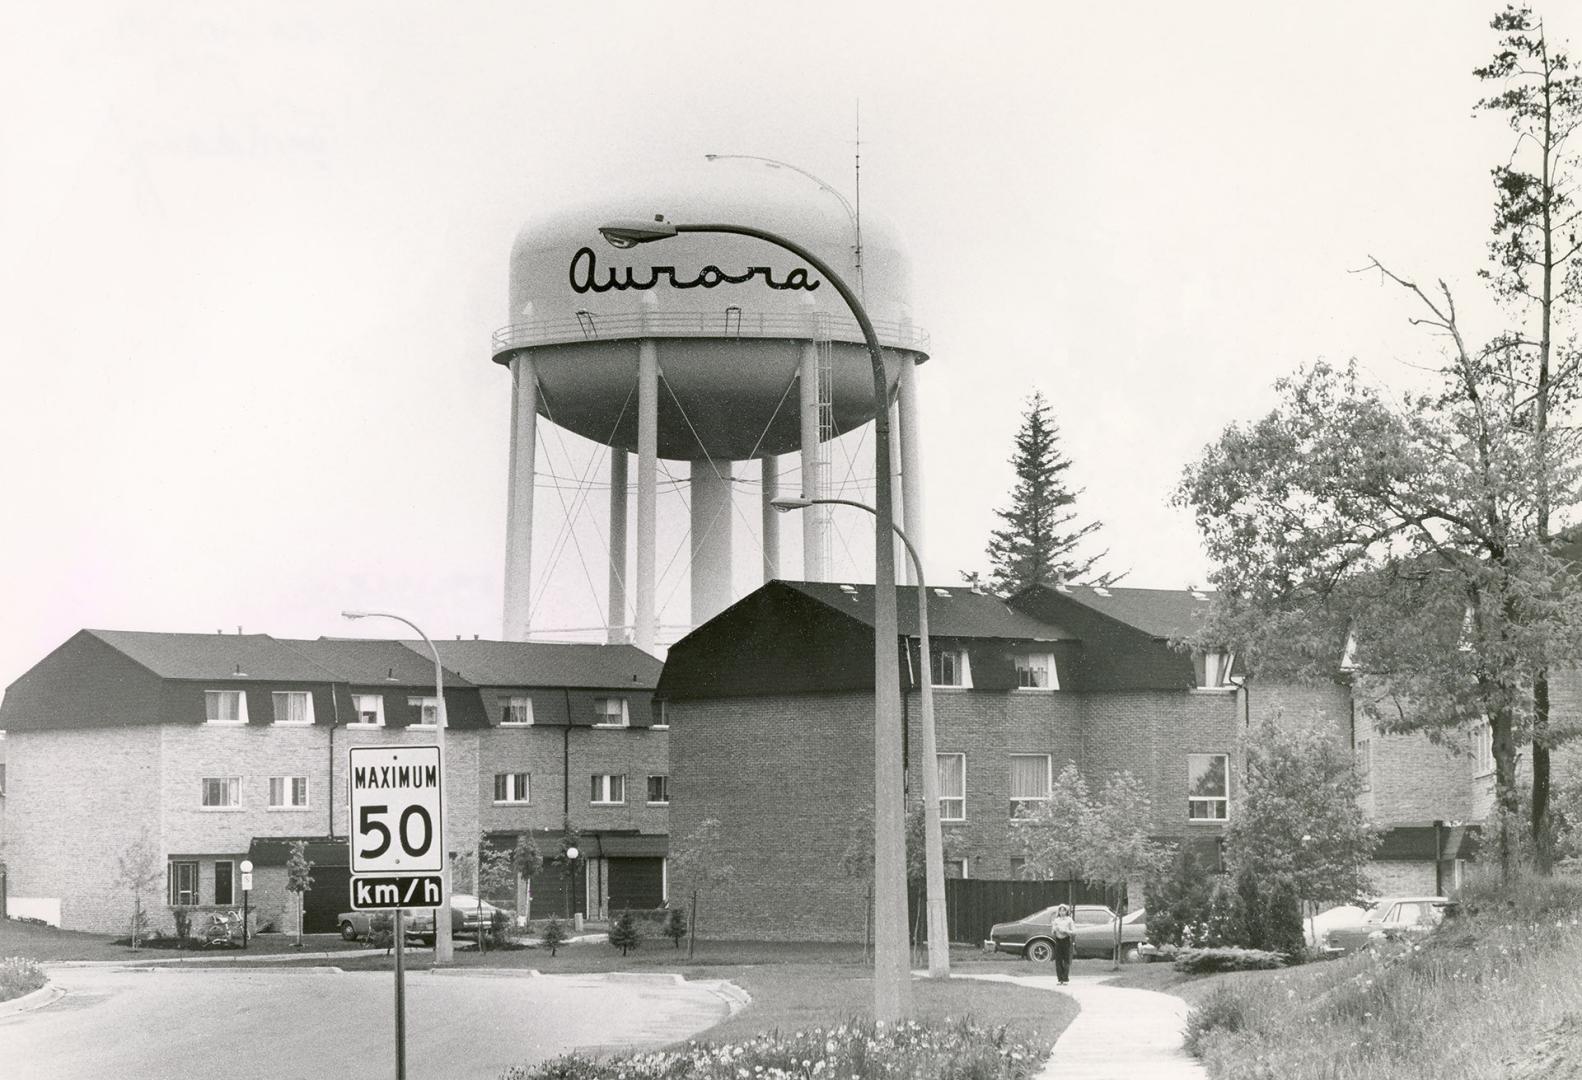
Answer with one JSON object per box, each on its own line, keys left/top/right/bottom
{"left": 494, "top": 158, "right": 927, "bottom": 651}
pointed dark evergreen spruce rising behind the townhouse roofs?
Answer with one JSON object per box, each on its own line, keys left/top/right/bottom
{"left": 968, "top": 392, "right": 1115, "bottom": 596}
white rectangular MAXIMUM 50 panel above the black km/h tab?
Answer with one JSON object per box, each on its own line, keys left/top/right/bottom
{"left": 346, "top": 746, "right": 445, "bottom": 874}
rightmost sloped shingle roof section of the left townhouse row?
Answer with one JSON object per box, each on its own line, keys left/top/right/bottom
{"left": 423, "top": 640, "right": 664, "bottom": 689}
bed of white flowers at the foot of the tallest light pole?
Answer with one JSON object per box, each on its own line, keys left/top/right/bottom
{"left": 501, "top": 1020, "right": 1052, "bottom": 1080}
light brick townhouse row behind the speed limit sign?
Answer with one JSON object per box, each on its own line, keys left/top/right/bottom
{"left": 0, "top": 629, "right": 669, "bottom": 931}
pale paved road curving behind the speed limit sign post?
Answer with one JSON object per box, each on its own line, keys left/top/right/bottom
{"left": 0, "top": 968, "right": 729, "bottom": 1080}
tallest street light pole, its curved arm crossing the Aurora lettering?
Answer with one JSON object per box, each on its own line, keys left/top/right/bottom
{"left": 600, "top": 215, "right": 911, "bottom": 1023}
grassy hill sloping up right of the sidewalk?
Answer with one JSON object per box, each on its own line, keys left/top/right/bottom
{"left": 1156, "top": 878, "right": 1582, "bottom": 1080}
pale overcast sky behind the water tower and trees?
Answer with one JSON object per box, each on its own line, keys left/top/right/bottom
{"left": 0, "top": 0, "right": 1556, "bottom": 685}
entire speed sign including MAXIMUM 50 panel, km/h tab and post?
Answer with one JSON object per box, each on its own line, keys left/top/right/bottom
{"left": 346, "top": 746, "right": 445, "bottom": 1080}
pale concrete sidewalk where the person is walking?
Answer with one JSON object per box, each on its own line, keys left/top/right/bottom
{"left": 952, "top": 974, "right": 1207, "bottom": 1080}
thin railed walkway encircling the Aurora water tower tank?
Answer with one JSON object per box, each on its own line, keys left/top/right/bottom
{"left": 494, "top": 307, "right": 929, "bottom": 357}
